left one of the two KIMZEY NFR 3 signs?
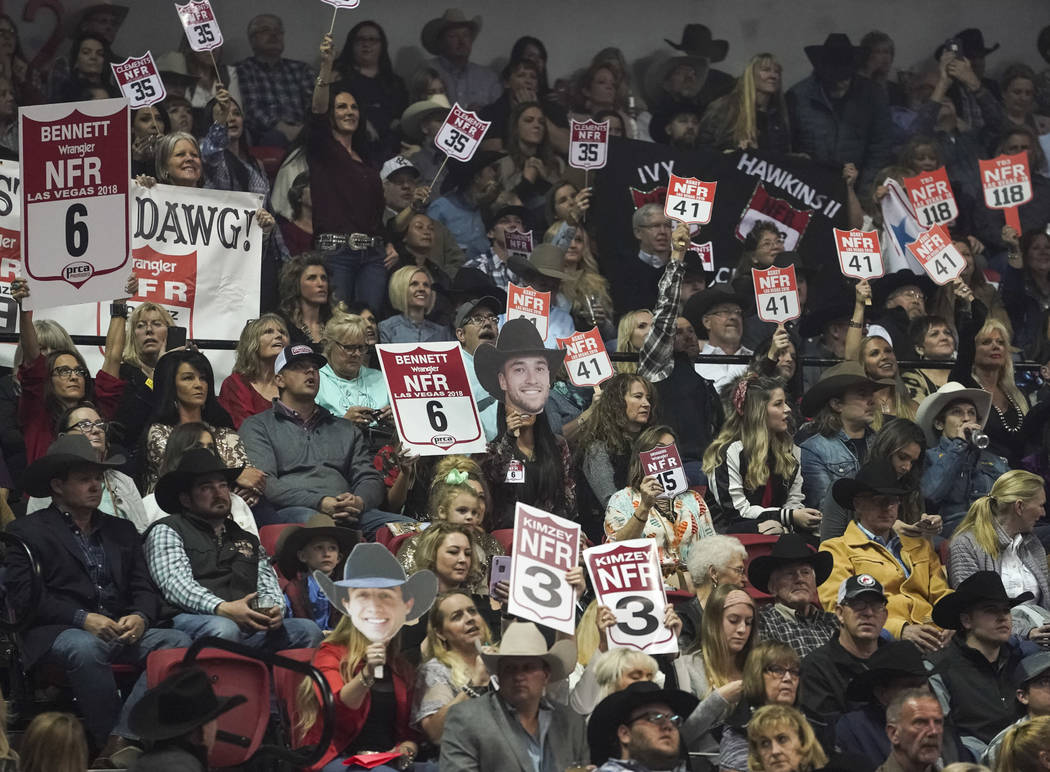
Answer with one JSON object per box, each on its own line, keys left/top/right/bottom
{"left": 507, "top": 501, "right": 580, "bottom": 634}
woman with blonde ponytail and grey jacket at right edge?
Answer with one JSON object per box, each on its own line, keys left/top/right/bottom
{"left": 948, "top": 470, "right": 1050, "bottom": 645}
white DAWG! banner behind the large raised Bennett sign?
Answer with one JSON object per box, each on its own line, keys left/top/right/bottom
{"left": 0, "top": 175, "right": 263, "bottom": 380}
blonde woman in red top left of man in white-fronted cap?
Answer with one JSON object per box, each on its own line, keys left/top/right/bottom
{"left": 218, "top": 314, "right": 288, "bottom": 429}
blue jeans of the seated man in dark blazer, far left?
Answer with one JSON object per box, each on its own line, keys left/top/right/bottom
{"left": 44, "top": 627, "right": 191, "bottom": 748}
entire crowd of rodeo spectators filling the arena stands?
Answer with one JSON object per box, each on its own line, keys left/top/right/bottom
{"left": 0, "top": 4, "right": 1050, "bottom": 772}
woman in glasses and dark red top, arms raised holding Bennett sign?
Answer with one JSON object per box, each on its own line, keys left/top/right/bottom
{"left": 11, "top": 278, "right": 127, "bottom": 464}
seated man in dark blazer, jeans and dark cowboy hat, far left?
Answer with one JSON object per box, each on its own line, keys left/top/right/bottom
{"left": 4, "top": 435, "right": 190, "bottom": 767}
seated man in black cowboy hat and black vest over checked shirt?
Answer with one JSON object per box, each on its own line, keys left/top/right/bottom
{"left": 146, "top": 448, "right": 321, "bottom": 651}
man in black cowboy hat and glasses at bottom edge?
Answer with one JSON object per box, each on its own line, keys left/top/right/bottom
{"left": 587, "top": 681, "right": 700, "bottom": 772}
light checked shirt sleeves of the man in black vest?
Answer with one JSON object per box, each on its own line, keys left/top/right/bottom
{"left": 146, "top": 523, "right": 285, "bottom": 613}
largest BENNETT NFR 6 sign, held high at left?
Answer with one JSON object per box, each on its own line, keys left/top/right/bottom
{"left": 19, "top": 99, "right": 131, "bottom": 309}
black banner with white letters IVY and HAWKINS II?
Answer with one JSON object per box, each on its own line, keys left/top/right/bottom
{"left": 590, "top": 138, "right": 847, "bottom": 292}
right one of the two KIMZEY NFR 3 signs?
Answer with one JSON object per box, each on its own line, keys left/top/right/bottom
{"left": 584, "top": 539, "right": 678, "bottom": 654}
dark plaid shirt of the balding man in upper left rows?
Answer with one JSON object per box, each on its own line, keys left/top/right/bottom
{"left": 237, "top": 57, "right": 316, "bottom": 138}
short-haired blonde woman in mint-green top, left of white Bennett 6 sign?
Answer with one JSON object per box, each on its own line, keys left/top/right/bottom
{"left": 316, "top": 313, "right": 391, "bottom": 429}
